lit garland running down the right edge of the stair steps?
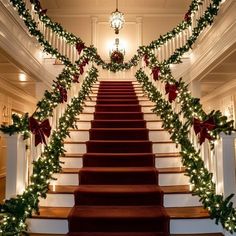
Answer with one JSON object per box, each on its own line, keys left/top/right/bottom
{"left": 136, "top": 69, "right": 236, "bottom": 233}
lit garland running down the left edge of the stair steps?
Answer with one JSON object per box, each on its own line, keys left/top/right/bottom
{"left": 0, "top": 67, "right": 98, "bottom": 235}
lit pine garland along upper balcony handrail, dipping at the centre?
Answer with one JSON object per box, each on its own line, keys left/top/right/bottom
{"left": 10, "top": 0, "right": 214, "bottom": 72}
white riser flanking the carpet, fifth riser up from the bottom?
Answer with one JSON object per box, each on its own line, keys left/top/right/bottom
{"left": 65, "top": 143, "right": 179, "bottom": 154}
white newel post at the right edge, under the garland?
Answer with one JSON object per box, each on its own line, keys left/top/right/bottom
{"left": 216, "top": 133, "right": 236, "bottom": 204}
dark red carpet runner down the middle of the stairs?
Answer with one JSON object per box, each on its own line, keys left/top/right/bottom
{"left": 68, "top": 82, "right": 169, "bottom": 236}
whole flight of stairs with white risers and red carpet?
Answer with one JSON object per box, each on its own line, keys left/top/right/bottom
{"left": 28, "top": 81, "right": 222, "bottom": 236}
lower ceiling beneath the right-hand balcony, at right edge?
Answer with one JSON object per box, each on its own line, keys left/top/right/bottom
{"left": 200, "top": 48, "right": 236, "bottom": 96}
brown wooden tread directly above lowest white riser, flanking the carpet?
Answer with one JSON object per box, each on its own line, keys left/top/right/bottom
{"left": 33, "top": 206, "right": 209, "bottom": 219}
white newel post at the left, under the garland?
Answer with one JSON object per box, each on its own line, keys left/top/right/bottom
{"left": 4, "top": 134, "right": 27, "bottom": 199}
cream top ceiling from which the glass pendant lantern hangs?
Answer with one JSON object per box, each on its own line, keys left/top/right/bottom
{"left": 41, "top": 0, "right": 191, "bottom": 16}
